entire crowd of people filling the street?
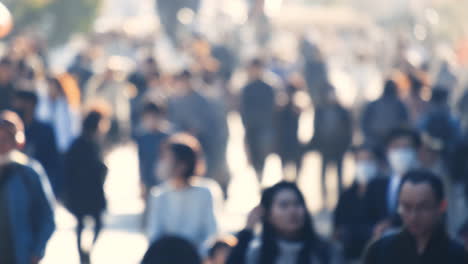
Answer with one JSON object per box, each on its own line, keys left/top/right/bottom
{"left": 0, "top": 17, "right": 468, "bottom": 264}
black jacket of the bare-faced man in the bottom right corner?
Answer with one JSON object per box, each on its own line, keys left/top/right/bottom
{"left": 364, "top": 227, "right": 468, "bottom": 264}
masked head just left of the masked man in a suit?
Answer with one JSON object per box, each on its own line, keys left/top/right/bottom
{"left": 353, "top": 144, "right": 379, "bottom": 184}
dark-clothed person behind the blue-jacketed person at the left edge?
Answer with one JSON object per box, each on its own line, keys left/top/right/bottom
{"left": 12, "top": 90, "right": 61, "bottom": 195}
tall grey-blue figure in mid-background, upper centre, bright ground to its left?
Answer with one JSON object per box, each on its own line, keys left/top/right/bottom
{"left": 240, "top": 59, "right": 275, "bottom": 183}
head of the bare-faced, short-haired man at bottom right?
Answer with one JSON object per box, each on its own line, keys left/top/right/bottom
{"left": 398, "top": 170, "right": 447, "bottom": 238}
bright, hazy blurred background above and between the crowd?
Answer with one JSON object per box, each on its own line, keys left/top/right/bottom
{"left": 0, "top": 0, "right": 468, "bottom": 264}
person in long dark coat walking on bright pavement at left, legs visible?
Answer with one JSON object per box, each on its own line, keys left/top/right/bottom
{"left": 64, "top": 111, "right": 110, "bottom": 263}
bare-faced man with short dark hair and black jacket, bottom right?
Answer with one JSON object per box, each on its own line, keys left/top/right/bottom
{"left": 364, "top": 170, "right": 468, "bottom": 264}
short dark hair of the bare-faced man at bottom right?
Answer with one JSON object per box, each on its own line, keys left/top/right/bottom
{"left": 400, "top": 169, "right": 445, "bottom": 203}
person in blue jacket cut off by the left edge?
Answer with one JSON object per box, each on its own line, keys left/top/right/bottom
{"left": 0, "top": 111, "right": 55, "bottom": 264}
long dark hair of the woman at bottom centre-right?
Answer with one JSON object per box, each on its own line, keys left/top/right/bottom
{"left": 259, "top": 181, "right": 320, "bottom": 264}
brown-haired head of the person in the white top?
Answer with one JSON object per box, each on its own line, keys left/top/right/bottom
{"left": 156, "top": 134, "right": 201, "bottom": 183}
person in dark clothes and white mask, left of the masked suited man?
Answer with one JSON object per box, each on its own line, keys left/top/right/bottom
{"left": 334, "top": 145, "right": 380, "bottom": 263}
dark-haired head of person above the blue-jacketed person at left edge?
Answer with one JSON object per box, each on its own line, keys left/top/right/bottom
{"left": 12, "top": 90, "right": 39, "bottom": 124}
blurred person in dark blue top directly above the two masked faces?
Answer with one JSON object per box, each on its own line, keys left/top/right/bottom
{"left": 361, "top": 80, "right": 409, "bottom": 146}
